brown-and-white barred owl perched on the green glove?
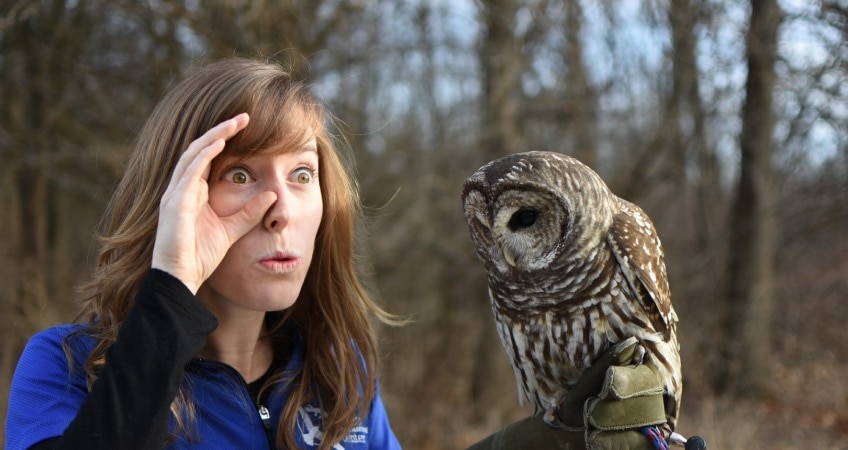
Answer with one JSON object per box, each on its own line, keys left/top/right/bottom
{"left": 462, "top": 152, "right": 682, "bottom": 430}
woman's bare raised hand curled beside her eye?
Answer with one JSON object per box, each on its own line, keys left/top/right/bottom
{"left": 152, "top": 113, "right": 277, "bottom": 293}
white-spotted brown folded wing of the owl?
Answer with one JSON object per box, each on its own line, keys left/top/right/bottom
{"left": 608, "top": 199, "right": 677, "bottom": 337}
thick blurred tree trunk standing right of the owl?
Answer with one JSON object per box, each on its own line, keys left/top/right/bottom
{"left": 720, "top": 0, "right": 781, "bottom": 395}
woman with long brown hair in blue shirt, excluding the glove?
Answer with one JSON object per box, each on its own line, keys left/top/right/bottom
{"left": 6, "top": 59, "right": 399, "bottom": 449}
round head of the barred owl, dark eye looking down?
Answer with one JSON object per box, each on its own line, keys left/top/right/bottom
{"left": 462, "top": 152, "right": 612, "bottom": 275}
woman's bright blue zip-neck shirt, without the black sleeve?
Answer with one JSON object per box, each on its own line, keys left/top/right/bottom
{"left": 6, "top": 325, "right": 400, "bottom": 450}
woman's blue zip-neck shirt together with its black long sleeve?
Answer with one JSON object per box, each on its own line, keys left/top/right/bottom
{"left": 6, "top": 269, "right": 400, "bottom": 450}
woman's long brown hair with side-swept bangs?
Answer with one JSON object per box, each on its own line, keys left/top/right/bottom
{"left": 77, "top": 58, "right": 394, "bottom": 450}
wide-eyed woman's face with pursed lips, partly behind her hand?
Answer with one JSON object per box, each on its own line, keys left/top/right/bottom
{"left": 197, "top": 139, "right": 323, "bottom": 318}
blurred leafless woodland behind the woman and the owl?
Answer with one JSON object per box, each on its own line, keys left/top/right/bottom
{"left": 0, "top": 0, "right": 848, "bottom": 449}
